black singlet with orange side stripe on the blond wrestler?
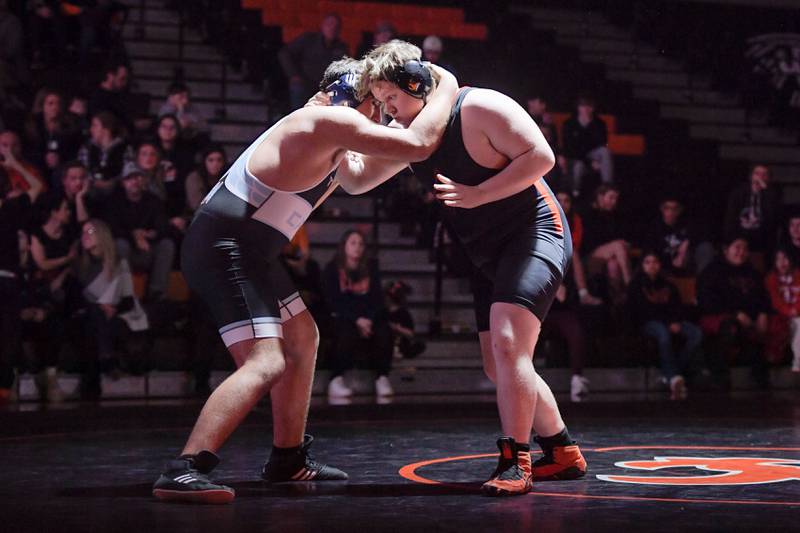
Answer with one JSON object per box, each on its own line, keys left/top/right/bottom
{"left": 412, "top": 88, "right": 572, "bottom": 331}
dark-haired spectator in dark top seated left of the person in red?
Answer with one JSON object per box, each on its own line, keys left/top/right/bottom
{"left": 697, "top": 237, "right": 770, "bottom": 386}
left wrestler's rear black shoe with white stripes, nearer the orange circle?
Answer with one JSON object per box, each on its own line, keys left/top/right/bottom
{"left": 261, "top": 435, "right": 347, "bottom": 483}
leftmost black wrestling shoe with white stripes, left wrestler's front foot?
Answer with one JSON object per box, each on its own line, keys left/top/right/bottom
{"left": 153, "top": 450, "right": 236, "bottom": 504}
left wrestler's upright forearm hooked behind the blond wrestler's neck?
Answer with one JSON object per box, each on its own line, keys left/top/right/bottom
{"left": 407, "top": 66, "right": 458, "bottom": 161}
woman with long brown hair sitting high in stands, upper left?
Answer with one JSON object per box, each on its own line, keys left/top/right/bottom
{"left": 25, "top": 89, "right": 81, "bottom": 179}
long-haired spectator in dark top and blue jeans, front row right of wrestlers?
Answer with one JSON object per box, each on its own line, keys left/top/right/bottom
{"left": 628, "top": 251, "right": 703, "bottom": 400}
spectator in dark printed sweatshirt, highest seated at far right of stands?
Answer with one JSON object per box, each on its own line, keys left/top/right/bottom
{"left": 724, "top": 165, "right": 781, "bottom": 256}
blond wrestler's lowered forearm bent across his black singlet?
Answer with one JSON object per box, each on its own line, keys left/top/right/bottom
{"left": 476, "top": 147, "right": 555, "bottom": 204}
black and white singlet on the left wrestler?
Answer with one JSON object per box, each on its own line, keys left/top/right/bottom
{"left": 181, "top": 123, "right": 335, "bottom": 346}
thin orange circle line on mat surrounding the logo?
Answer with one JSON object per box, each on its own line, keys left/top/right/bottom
{"left": 398, "top": 446, "right": 800, "bottom": 506}
